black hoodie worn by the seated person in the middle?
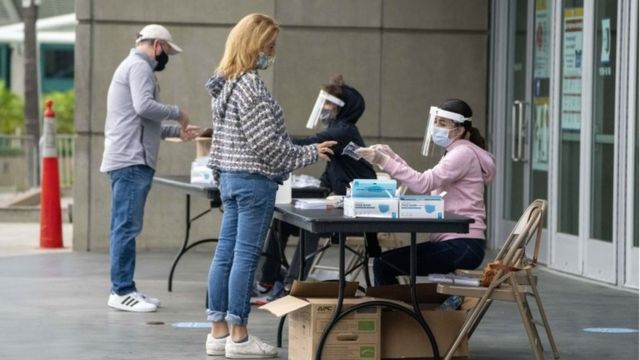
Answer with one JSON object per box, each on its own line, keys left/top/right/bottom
{"left": 293, "top": 85, "right": 376, "bottom": 195}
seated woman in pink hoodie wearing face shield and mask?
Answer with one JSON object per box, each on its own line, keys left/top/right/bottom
{"left": 358, "top": 99, "right": 496, "bottom": 285}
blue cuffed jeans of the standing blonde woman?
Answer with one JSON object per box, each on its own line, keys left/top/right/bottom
{"left": 207, "top": 173, "right": 278, "bottom": 325}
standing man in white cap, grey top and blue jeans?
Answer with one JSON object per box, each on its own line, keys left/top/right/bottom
{"left": 100, "top": 24, "right": 198, "bottom": 312}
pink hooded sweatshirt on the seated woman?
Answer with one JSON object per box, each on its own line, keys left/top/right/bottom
{"left": 382, "top": 140, "right": 496, "bottom": 241}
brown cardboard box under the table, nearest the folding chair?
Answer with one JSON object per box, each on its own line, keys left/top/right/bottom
{"left": 367, "top": 283, "right": 477, "bottom": 359}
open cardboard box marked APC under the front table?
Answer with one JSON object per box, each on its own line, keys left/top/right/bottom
{"left": 260, "top": 281, "right": 381, "bottom": 360}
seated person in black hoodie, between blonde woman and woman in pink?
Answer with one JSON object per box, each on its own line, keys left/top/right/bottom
{"left": 256, "top": 75, "right": 380, "bottom": 302}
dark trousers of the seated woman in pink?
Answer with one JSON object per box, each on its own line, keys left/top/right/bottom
{"left": 373, "top": 239, "right": 484, "bottom": 286}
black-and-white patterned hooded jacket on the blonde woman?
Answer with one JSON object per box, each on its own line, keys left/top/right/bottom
{"left": 206, "top": 71, "right": 318, "bottom": 183}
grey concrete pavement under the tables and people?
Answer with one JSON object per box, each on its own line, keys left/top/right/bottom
{"left": 0, "top": 223, "right": 638, "bottom": 360}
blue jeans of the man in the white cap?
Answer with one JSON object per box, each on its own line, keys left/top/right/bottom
{"left": 109, "top": 165, "right": 155, "bottom": 295}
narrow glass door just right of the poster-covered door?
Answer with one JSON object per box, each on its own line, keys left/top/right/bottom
{"left": 584, "top": 0, "right": 619, "bottom": 283}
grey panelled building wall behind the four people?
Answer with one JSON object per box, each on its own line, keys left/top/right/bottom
{"left": 73, "top": 0, "right": 489, "bottom": 251}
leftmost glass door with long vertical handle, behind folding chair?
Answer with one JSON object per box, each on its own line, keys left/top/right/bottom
{"left": 494, "top": 0, "right": 553, "bottom": 262}
